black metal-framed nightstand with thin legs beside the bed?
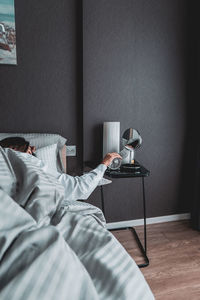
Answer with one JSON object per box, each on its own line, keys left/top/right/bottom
{"left": 101, "top": 162, "right": 150, "bottom": 268}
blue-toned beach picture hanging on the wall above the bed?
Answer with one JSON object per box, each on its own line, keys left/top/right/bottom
{"left": 0, "top": 0, "right": 17, "bottom": 65}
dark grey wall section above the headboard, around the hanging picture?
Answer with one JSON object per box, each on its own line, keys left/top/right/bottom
{"left": 0, "top": 0, "right": 82, "bottom": 173}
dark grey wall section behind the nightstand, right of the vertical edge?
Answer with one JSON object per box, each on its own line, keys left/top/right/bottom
{"left": 83, "top": 0, "right": 189, "bottom": 221}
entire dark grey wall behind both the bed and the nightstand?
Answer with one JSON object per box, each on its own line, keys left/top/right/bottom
{"left": 0, "top": 0, "right": 192, "bottom": 221}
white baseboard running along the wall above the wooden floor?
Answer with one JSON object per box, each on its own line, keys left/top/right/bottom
{"left": 106, "top": 213, "right": 190, "bottom": 229}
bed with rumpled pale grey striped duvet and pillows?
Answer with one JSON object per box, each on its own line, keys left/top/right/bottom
{"left": 0, "top": 134, "right": 154, "bottom": 300}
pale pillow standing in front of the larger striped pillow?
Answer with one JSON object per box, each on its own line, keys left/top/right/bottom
{"left": 35, "top": 144, "right": 58, "bottom": 172}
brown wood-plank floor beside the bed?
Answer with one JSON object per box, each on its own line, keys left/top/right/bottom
{"left": 111, "top": 221, "right": 200, "bottom": 300}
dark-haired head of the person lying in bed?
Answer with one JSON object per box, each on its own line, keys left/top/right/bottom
{"left": 0, "top": 136, "right": 36, "bottom": 155}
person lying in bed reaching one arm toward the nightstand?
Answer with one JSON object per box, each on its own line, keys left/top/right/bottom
{"left": 0, "top": 137, "right": 121, "bottom": 201}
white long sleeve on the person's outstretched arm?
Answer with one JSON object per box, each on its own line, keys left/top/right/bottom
{"left": 58, "top": 164, "right": 107, "bottom": 200}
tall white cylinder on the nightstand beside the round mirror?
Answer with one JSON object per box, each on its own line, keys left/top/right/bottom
{"left": 103, "top": 122, "right": 120, "bottom": 157}
